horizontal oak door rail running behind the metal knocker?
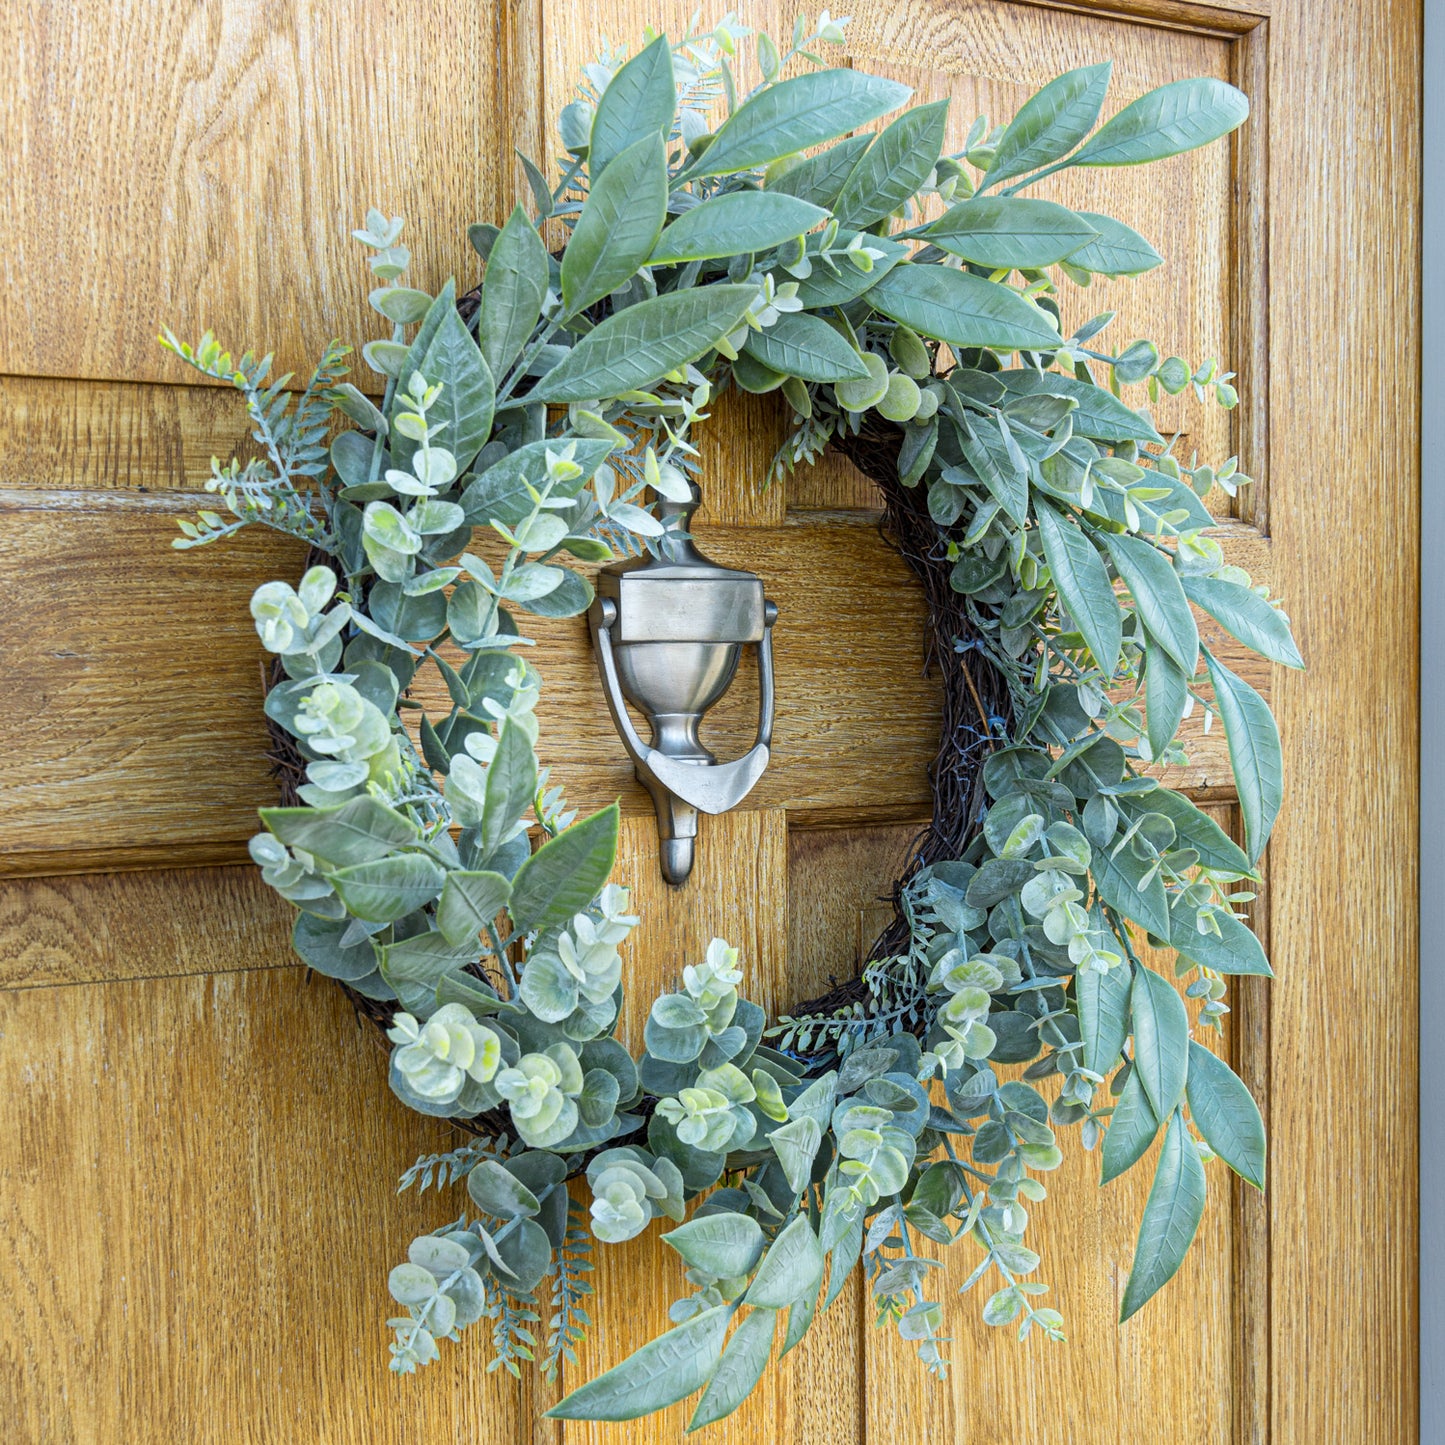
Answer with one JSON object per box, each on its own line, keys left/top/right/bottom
{"left": 0, "top": 493, "right": 1270, "bottom": 874}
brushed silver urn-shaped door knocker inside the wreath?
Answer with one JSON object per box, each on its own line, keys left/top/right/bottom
{"left": 588, "top": 487, "right": 777, "bottom": 884}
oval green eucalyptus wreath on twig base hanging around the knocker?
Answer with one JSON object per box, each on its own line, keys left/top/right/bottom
{"left": 165, "top": 13, "right": 1301, "bottom": 1428}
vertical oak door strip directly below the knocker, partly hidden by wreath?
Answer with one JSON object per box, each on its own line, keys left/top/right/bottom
{"left": 561, "top": 809, "right": 796, "bottom": 1445}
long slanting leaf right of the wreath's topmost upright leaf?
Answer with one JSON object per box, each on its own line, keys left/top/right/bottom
{"left": 686, "top": 69, "right": 913, "bottom": 179}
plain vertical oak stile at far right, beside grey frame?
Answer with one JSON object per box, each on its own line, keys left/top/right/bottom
{"left": 1269, "top": 0, "right": 1421, "bottom": 1441}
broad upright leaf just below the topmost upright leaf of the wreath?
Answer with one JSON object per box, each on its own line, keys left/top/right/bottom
{"left": 562, "top": 134, "right": 668, "bottom": 316}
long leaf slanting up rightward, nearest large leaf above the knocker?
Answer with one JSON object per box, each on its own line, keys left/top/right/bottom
{"left": 527, "top": 286, "right": 757, "bottom": 405}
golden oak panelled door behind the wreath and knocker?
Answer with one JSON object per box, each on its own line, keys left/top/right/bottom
{"left": 0, "top": 0, "right": 1420, "bottom": 1445}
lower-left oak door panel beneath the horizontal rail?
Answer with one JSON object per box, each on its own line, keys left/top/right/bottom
{"left": 0, "top": 953, "right": 532, "bottom": 1445}
